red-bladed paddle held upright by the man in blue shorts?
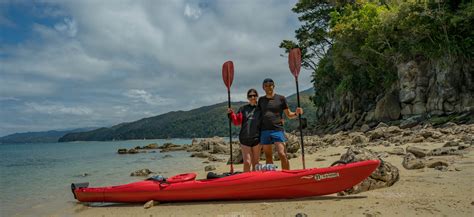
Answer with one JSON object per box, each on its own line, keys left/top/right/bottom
{"left": 288, "top": 48, "right": 306, "bottom": 169}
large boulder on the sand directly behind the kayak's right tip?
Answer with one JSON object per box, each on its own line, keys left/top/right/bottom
{"left": 339, "top": 147, "right": 400, "bottom": 195}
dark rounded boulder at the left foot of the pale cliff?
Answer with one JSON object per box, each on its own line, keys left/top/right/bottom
{"left": 375, "top": 93, "right": 400, "bottom": 121}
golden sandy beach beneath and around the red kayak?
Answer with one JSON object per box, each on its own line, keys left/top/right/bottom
{"left": 57, "top": 132, "right": 474, "bottom": 217}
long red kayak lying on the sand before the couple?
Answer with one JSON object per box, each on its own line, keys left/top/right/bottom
{"left": 71, "top": 160, "right": 380, "bottom": 203}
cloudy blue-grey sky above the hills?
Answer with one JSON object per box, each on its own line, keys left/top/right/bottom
{"left": 0, "top": 0, "right": 312, "bottom": 136}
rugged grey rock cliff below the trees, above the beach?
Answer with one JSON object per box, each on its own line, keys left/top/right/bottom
{"left": 315, "top": 58, "right": 474, "bottom": 132}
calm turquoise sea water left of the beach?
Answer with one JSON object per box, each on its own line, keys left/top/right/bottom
{"left": 0, "top": 139, "right": 203, "bottom": 216}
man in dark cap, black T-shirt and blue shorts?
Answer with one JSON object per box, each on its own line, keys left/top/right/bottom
{"left": 258, "top": 78, "right": 303, "bottom": 170}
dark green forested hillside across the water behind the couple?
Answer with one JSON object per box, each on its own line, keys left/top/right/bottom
{"left": 59, "top": 89, "right": 316, "bottom": 142}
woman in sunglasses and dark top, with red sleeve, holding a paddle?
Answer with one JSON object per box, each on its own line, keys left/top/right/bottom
{"left": 227, "top": 89, "right": 262, "bottom": 172}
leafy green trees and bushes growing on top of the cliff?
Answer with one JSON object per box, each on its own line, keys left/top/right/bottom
{"left": 280, "top": 0, "right": 474, "bottom": 112}
